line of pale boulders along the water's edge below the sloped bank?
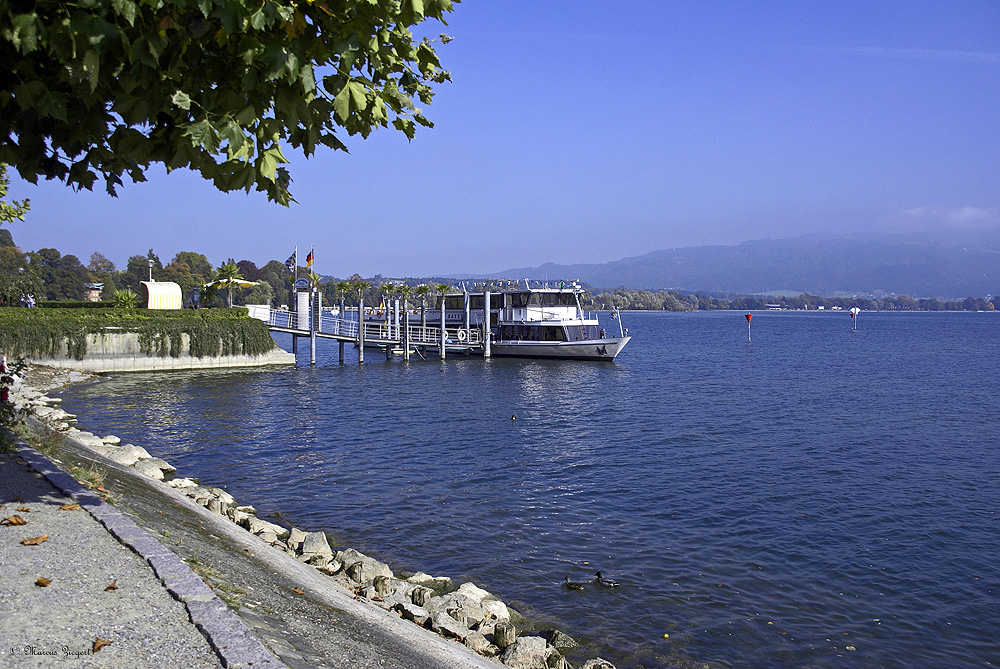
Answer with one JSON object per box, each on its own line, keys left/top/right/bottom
{"left": 13, "top": 370, "right": 614, "bottom": 669}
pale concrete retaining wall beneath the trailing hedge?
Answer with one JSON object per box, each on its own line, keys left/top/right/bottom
{"left": 31, "top": 332, "right": 295, "bottom": 372}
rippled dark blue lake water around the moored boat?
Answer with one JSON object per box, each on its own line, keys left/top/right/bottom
{"left": 56, "top": 312, "right": 1000, "bottom": 667}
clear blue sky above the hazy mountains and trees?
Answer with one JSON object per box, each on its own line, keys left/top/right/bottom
{"left": 10, "top": 0, "right": 1000, "bottom": 277}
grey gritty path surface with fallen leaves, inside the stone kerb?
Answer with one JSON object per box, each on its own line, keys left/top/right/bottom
{"left": 0, "top": 446, "right": 222, "bottom": 668}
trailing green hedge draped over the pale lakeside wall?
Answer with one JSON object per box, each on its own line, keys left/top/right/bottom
{"left": 0, "top": 307, "right": 276, "bottom": 360}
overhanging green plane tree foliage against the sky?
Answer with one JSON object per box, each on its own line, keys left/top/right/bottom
{"left": 0, "top": 0, "right": 458, "bottom": 204}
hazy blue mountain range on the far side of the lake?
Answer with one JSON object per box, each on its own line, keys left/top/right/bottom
{"left": 472, "top": 231, "right": 1000, "bottom": 298}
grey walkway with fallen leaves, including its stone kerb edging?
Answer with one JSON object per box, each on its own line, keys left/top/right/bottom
{"left": 0, "top": 436, "right": 283, "bottom": 669}
